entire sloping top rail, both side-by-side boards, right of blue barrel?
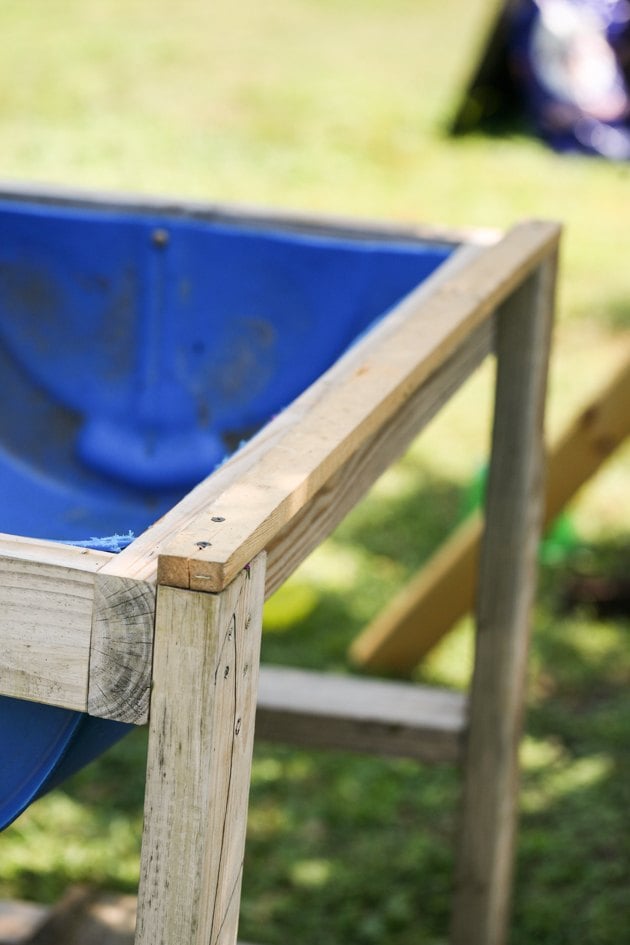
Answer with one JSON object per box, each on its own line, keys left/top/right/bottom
{"left": 94, "top": 223, "right": 559, "bottom": 592}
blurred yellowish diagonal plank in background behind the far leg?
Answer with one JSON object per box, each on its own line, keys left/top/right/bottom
{"left": 350, "top": 332, "right": 630, "bottom": 671}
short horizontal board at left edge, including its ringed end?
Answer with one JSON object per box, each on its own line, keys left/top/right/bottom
{"left": 0, "top": 535, "right": 155, "bottom": 725}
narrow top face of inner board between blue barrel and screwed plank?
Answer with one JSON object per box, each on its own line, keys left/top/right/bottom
{"left": 103, "top": 240, "right": 482, "bottom": 583}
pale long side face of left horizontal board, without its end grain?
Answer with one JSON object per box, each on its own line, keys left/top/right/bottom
{"left": 0, "top": 535, "right": 111, "bottom": 711}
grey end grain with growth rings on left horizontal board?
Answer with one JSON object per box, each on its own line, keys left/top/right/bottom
{"left": 87, "top": 574, "right": 156, "bottom": 725}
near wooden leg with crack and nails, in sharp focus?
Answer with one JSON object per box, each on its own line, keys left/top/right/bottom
{"left": 135, "top": 553, "right": 265, "bottom": 945}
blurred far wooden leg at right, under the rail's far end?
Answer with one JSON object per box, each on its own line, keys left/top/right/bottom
{"left": 452, "top": 259, "right": 555, "bottom": 945}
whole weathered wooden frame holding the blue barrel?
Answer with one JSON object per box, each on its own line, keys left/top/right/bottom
{"left": 0, "top": 183, "right": 559, "bottom": 945}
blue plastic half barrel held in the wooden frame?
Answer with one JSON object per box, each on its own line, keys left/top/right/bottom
{"left": 0, "top": 200, "right": 452, "bottom": 828}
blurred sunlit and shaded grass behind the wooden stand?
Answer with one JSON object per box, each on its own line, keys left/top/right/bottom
{"left": 0, "top": 0, "right": 630, "bottom": 945}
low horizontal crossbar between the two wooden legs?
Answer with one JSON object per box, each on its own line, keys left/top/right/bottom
{"left": 256, "top": 665, "right": 466, "bottom": 762}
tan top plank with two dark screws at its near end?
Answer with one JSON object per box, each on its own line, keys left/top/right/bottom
{"left": 143, "top": 223, "right": 559, "bottom": 591}
